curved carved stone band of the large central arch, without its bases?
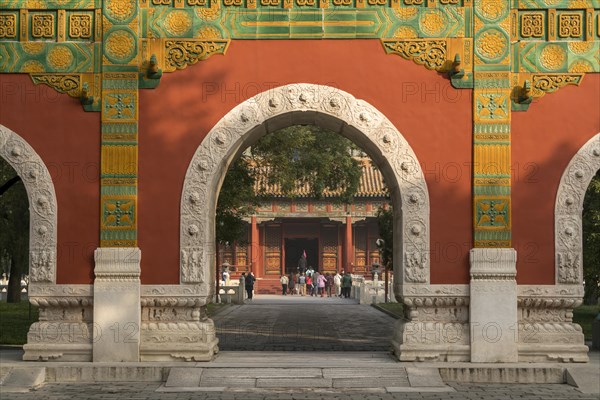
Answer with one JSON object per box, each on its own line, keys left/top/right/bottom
{"left": 180, "top": 84, "right": 429, "bottom": 295}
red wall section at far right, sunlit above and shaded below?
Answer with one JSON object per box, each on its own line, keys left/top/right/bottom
{"left": 512, "top": 74, "right": 600, "bottom": 285}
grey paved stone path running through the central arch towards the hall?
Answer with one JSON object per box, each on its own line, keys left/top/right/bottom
{"left": 213, "top": 295, "right": 396, "bottom": 351}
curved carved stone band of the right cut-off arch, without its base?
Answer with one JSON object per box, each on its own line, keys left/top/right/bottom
{"left": 554, "top": 133, "right": 600, "bottom": 285}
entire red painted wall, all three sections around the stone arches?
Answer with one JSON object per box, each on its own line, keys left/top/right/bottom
{"left": 0, "top": 40, "right": 600, "bottom": 284}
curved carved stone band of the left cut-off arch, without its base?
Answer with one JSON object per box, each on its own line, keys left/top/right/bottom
{"left": 0, "top": 125, "right": 58, "bottom": 289}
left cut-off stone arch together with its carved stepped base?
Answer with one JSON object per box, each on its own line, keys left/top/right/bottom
{"left": 0, "top": 125, "right": 93, "bottom": 361}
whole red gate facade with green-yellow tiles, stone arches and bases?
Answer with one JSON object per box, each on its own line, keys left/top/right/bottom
{"left": 0, "top": 0, "right": 600, "bottom": 362}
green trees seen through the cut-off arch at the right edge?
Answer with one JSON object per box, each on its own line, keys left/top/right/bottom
{"left": 582, "top": 171, "right": 600, "bottom": 304}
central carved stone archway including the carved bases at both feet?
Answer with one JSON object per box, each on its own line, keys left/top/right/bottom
{"left": 162, "top": 84, "right": 476, "bottom": 360}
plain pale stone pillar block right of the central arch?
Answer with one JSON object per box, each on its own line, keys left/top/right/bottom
{"left": 469, "top": 248, "right": 518, "bottom": 362}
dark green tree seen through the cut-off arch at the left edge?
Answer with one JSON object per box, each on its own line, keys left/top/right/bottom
{"left": 0, "top": 157, "right": 29, "bottom": 303}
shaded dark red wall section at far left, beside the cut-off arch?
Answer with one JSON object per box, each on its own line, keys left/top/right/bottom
{"left": 0, "top": 74, "right": 100, "bottom": 283}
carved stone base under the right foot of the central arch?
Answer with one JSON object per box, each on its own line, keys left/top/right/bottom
{"left": 392, "top": 285, "right": 470, "bottom": 361}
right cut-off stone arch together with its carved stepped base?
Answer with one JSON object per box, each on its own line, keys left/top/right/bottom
{"left": 510, "top": 133, "right": 600, "bottom": 362}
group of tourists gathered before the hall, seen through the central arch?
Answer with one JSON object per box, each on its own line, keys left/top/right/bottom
{"left": 279, "top": 267, "right": 352, "bottom": 298}
